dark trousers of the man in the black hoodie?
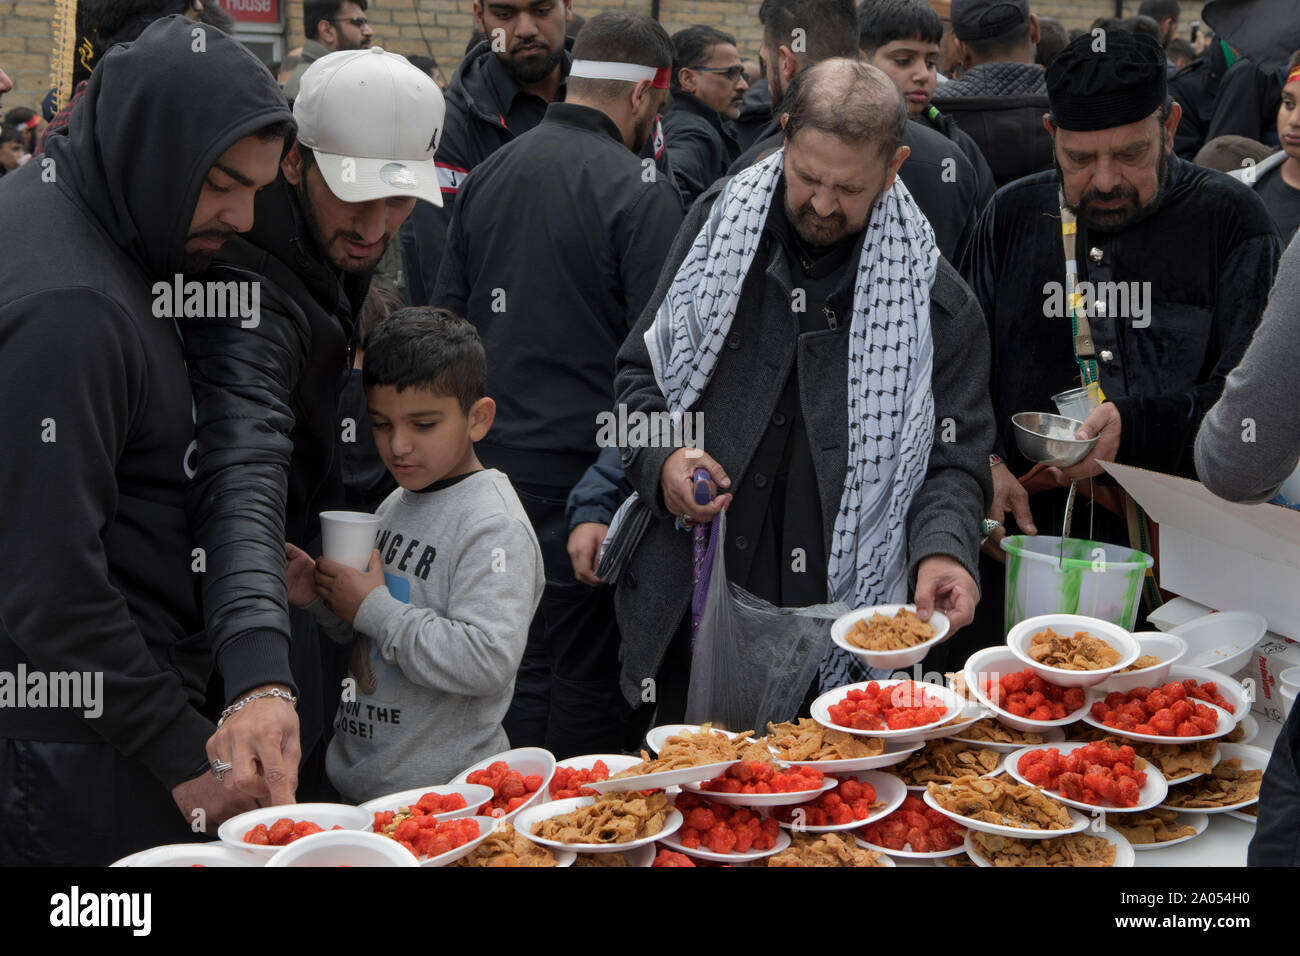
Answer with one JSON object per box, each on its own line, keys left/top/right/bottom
{"left": 0, "top": 739, "right": 202, "bottom": 866}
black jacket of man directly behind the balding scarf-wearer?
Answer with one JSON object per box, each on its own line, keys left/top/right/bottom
{"left": 727, "top": 120, "right": 979, "bottom": 263}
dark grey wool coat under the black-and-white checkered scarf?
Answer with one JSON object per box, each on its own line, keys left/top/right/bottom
{"left": 614, "top": 181, "right": 995, "bottom": 706}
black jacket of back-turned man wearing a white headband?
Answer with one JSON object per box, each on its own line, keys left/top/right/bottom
{"left": 433, "top": 103, "right": 681, "bottom": 490}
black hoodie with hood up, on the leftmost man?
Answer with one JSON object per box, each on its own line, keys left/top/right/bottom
{"left": 0, "top": 16, "right": 293, "bottom": 788}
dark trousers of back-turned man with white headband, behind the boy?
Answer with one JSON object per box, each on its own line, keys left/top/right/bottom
{"left": 503, "top": 481, "right": 632, "bottom": 760}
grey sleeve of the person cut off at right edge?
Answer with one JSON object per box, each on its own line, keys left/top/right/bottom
{"left": 1196, "top": 235, "right": 1300, "bottom": 502}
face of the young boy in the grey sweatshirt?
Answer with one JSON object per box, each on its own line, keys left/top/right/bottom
{"left": 365, "top": 385, "right": 497, "bottom": 490}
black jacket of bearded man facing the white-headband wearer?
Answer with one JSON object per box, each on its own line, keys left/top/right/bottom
{"left": 402, "top": 38, "right": 672, "bottom": 306}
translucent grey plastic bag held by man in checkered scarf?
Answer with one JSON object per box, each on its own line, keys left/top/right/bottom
{"left": 686, "top": 511, "right": 849, "bottom": 734}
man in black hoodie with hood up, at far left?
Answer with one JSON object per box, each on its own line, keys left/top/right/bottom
{"left": 0, "top": 17, "right": 293, "bottom": 865}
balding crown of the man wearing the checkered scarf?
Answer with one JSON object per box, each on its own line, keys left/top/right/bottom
{"left": 784, "top": 59, "right": 907, "bottom": 156}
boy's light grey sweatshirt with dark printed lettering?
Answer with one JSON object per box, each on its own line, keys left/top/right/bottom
{"left": 312, "top": 470, "right": 546, "bottom": 803}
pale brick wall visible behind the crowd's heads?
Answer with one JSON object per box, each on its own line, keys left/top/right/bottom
{"left": 0, "top": 0, "right": 1138, "bottom": 109}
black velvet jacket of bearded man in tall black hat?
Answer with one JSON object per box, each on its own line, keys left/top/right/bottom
{"left": 961, "top": 157, "right": 1282, "bottom": 486}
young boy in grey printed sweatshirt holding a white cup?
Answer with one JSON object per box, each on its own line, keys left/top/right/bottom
{"left": 286, "top": 308, "right": 545, "bottom": 803}
